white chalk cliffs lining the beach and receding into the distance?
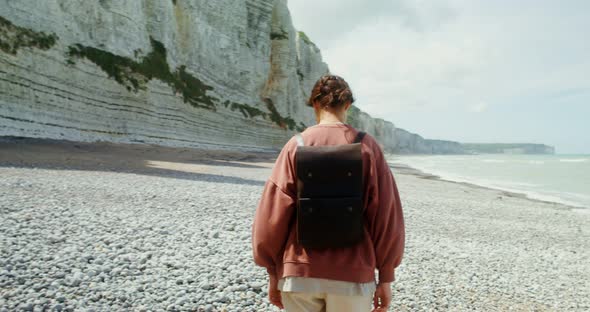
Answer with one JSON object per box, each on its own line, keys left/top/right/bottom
{"left": 0, "top": 0, "right": 553, "bottom": 154}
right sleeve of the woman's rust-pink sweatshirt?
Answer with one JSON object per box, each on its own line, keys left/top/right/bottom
{"left": 367, "top": 144, "right": 405, "bottom": 283}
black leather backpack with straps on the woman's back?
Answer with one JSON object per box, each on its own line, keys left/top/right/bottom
{"left": 295, "top": 132, "right": 365, "bottom": 248}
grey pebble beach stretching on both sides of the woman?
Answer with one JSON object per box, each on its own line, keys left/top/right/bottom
{"left": 0, "top": 140, "right": 590, "bottom": 311}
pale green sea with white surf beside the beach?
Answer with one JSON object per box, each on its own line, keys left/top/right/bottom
{"left": 386, "top": 154, "right": 590, "bottom": 209}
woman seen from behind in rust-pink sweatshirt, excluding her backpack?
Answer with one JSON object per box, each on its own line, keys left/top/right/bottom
{"left": 252, "top": 75, "right": 405, "bottom": 312}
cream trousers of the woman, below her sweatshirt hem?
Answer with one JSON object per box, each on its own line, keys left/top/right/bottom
{"left": 281, "top": 291, "right": 373, "bottom": 312}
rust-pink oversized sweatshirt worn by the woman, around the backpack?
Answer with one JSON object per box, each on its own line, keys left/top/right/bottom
{"left": 252, "top": 124, "right": 405, "bottom": 283}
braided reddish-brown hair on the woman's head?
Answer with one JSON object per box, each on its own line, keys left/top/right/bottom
{"left": 306, "top": 75, "right": 354, "bottom": 108}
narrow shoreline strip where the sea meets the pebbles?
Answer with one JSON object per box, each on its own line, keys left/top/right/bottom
{"left": 388, "top": 162, "right": 590, "bottom": 213}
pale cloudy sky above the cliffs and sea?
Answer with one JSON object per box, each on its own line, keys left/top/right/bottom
{"left": 288, "top": 0, "right": 590, "bottom": 154}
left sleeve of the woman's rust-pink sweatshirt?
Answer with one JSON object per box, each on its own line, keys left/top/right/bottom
{"left": 252, "top": 141, "right": 297, "bottom": 275}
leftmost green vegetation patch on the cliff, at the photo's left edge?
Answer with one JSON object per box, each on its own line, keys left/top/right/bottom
{"left": 0, "top": 16, "right": 59, "bottom": 55}
